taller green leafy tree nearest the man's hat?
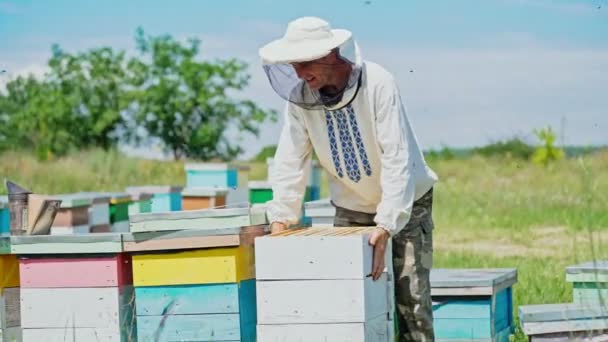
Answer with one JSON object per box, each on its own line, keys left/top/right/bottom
{"left": 128, "top": 28, "right": 276, "bottom": 160}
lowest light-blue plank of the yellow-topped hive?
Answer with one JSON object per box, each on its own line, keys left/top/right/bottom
{"left": 137, "top": 314, "right": 241, "bottom": 341}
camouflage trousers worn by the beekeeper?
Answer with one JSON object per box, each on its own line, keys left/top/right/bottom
{"left": 334, "top": 189, "right": 435, "bottom": 342}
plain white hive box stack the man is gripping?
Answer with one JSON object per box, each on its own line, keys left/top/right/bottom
{"left": 255, "top": 227, "right": 394, "bottom": 342}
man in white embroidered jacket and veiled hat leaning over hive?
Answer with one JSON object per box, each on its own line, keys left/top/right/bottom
{"left": 260, "top": 17, "right": 437, "bottom": 341}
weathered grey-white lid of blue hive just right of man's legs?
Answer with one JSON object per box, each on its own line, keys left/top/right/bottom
{"left": 431, "top": 268, "right": 517, "bottom": 296}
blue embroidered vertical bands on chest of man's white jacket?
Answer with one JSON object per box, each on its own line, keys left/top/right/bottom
{"left": 325, "top": 105, "right": 372, "bottom": 182}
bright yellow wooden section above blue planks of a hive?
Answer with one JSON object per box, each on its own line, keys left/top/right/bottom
{"left": 133, "top": 246, "right": 255, "bottom": 286}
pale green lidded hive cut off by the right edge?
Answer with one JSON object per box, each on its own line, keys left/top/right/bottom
{"left": 566, "top": 260, "right": 608, "bottom": 304}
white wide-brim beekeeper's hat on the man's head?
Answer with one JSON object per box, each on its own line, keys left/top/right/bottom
{"left": 259, "top": 17, "right": 352, "bottom": 64}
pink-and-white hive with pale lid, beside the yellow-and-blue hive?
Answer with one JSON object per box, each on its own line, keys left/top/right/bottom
{"left": 11, "top": 233, "right": 137, "bottom": 342}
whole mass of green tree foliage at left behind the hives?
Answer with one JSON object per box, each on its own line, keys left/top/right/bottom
{"left": 0, "top": 29, "right": 276, "bottom": 160}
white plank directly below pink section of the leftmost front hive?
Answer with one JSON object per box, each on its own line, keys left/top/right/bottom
{"left": 21, "top": 287, "right": 133, "bottom": 331}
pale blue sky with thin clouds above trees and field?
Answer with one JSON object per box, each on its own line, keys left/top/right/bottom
{"left": 0, "top": 0, "right": 608, "bottom": 158}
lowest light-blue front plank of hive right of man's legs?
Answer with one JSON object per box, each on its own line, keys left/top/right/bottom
{"left": 433, "top": 318, "right": 492, "bottom": 340}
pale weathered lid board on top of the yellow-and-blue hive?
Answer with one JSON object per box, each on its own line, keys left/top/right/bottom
{"left": 130, "top": 208, "right": 268, "bottom": 233}
